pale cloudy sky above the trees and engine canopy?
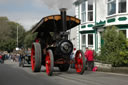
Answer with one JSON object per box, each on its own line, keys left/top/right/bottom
{"left": 0, "top": 0, "right": 75, "bottom": 30}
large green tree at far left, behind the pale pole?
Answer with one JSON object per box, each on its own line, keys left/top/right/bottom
{"left": 0, "top": 17, "right": 25, "bottom": 52}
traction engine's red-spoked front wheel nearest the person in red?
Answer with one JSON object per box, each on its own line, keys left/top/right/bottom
{"left": 75, "top": 50, "right": 86, "bottom": 74}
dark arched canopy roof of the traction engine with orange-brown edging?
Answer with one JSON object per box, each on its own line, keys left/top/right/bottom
{"left": 31, "top": 15, "right": 80, "bottom": 33}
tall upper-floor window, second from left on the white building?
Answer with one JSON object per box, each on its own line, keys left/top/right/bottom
{"left": 88, "top": 0, "right": 93, "bottom": 21}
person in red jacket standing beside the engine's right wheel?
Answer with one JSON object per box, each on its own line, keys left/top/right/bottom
{"left": 85, "top": 48, "right": 94, "bottom": 71}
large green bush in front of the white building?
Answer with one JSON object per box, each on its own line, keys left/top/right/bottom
{"left": 97, "top": 26, "right": 128, "bottom": 66}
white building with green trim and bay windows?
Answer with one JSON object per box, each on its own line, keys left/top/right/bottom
{"left": 74, "top": 0, "right": 128, "bottom": 52}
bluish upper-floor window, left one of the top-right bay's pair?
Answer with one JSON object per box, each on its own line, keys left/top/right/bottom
{"left": 108, "top": 0, "right": 116, "bottom": 15}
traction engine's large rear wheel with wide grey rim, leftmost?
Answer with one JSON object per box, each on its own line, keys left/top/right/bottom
{"left": 31, "top": 43, "right": 41, "bottom": 72}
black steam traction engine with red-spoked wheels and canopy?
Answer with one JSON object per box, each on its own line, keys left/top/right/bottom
{"left": 31, "top": 8, "right": 86, "bottom": 76}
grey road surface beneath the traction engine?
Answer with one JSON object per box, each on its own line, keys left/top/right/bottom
{"left": 0, "top": 60, "right": 128, "bottom": 85}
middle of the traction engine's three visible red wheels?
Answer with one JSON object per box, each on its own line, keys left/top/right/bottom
{"left": 45, "top": 50, "right": 54, "bottom": 76}
